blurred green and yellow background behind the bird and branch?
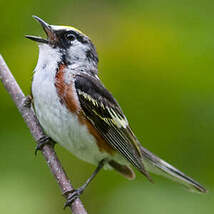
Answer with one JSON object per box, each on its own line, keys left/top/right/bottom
{"left": 0, "top": 0, "right": 214, "bottom": 214}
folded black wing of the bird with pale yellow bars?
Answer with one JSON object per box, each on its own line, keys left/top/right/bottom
{"left": 75, "top": 74, "right": 148, "bottom": 180}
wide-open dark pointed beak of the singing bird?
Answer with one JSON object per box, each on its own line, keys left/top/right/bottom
{"left": 25, "top": 16, "right": 57, "bottom": 44}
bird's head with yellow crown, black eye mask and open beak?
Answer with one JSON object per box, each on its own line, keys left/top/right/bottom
{"left": 25, "top": 16, "right": 98, "bottom": 67}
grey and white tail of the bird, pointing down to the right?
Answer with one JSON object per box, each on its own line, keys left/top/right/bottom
{"left": 141, "top": 146, "right": 207, "bottom": 193}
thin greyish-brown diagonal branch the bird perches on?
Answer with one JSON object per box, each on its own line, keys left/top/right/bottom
{"left": 0, "top": 55, "right": 87, "bottom": 214}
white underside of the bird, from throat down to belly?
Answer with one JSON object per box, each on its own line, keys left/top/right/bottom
{"left": 32, "top": 44, "right": 108, "bottom": 164}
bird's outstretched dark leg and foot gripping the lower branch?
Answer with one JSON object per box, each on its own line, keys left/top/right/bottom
{"left": 64, "top": 159, "right": 106, "bottom": 209}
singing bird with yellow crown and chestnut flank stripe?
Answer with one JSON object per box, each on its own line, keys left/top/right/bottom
{"left": 25, "top": 16, "right": 207, "bottom": 206}
